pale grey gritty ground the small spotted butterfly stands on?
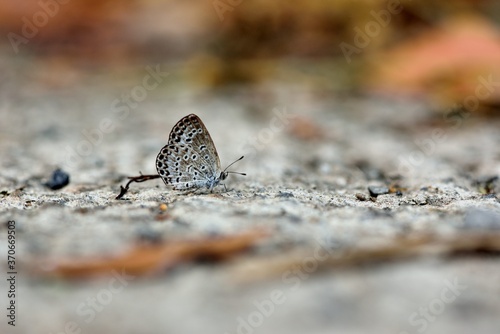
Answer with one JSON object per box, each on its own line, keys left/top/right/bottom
{"left": 0, "top": 58, "right": 500, "bottom": 334}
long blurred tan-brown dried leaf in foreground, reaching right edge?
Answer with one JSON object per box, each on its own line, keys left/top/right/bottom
{"left": 230, "top": 232, "right": 500, "bottom": 283}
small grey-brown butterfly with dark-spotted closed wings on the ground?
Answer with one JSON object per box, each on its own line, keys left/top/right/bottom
{"left": 156, "top": 114, "right": 246, "bottom": 191}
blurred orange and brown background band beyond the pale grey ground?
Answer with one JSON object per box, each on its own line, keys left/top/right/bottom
{"left": 0, "top": 0, "right": 500, "bottom": 113}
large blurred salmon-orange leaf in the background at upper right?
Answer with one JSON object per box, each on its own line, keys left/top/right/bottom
{"left": 369, "top": 16, "right": 500, "bottom": 109}
